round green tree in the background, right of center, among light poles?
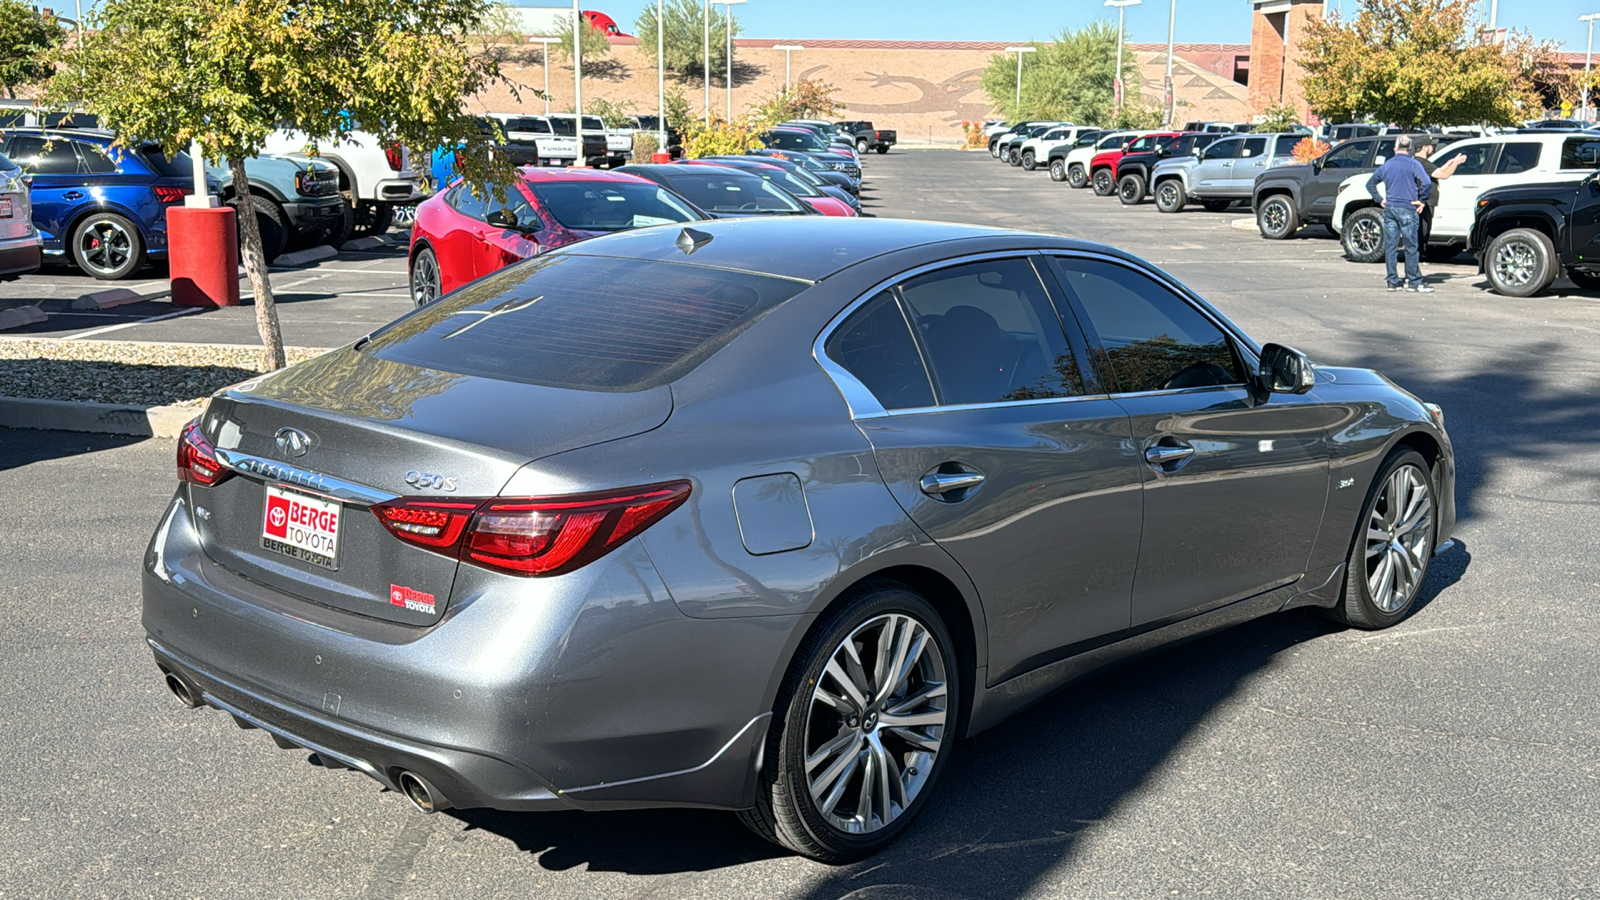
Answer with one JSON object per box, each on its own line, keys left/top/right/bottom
{"left": 979, "top": 22, "right": 1139, "bottom": 125}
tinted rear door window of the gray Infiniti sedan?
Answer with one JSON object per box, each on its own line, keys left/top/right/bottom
{"left": 899, "top": 259, "right": 1083, "bottom": 404}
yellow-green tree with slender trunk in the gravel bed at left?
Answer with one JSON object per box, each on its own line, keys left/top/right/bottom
{"left": 46, "top": 0, "right": 510, "bottom": 370}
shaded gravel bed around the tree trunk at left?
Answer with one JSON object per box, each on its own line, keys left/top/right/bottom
{"left": 0, "top": 338, "right": 326, "bottom": 407}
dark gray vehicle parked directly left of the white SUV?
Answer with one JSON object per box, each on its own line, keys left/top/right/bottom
{"left": 1250, "top": 135, "right": 1427, "bottom": 240}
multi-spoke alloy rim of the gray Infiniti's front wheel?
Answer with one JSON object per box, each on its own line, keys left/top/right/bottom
{"left": 1366, "top": 464, "right": 1434, "bottom": 613}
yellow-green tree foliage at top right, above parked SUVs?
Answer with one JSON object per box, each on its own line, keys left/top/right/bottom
{"left": 1301, "top": 0, "right": 1570, "bottom": 128}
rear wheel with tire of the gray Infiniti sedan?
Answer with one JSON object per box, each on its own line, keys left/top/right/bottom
{"left": 739, "top": 581, "right": 962, "bottom": 863}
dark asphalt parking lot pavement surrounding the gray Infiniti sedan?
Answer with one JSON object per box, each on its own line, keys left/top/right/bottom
{"left": 0, "top": 152, "right": 1600, "bottom": 900}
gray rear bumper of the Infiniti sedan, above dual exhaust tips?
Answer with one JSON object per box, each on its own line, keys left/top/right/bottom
{"left": 142, "top": 490, "right": 784, "bottom": 810}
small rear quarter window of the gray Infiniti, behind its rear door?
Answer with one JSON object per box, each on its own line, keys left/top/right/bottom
{"left": 822, "top": 291, "right": 933, "bottom": 410}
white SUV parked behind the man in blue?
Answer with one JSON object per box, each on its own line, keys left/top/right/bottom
{"left": 1330, "top": 131, "right": 1594, "bottom": 263}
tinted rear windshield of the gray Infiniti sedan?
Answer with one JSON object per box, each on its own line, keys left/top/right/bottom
{"left": 366, "top": 253, "right": 808, "bottom": 392}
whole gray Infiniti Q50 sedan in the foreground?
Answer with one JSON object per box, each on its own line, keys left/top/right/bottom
{"left": 144, "top": 216, "right": 1454, "bottom": 862}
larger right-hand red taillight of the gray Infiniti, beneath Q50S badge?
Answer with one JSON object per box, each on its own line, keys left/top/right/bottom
{"left": 373, "top": 482, "right": 690, "bottom": 575}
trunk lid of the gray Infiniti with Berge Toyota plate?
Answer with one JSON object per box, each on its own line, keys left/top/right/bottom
{"left": 190, "top": 348, "right": 672, "bottom": 626}
